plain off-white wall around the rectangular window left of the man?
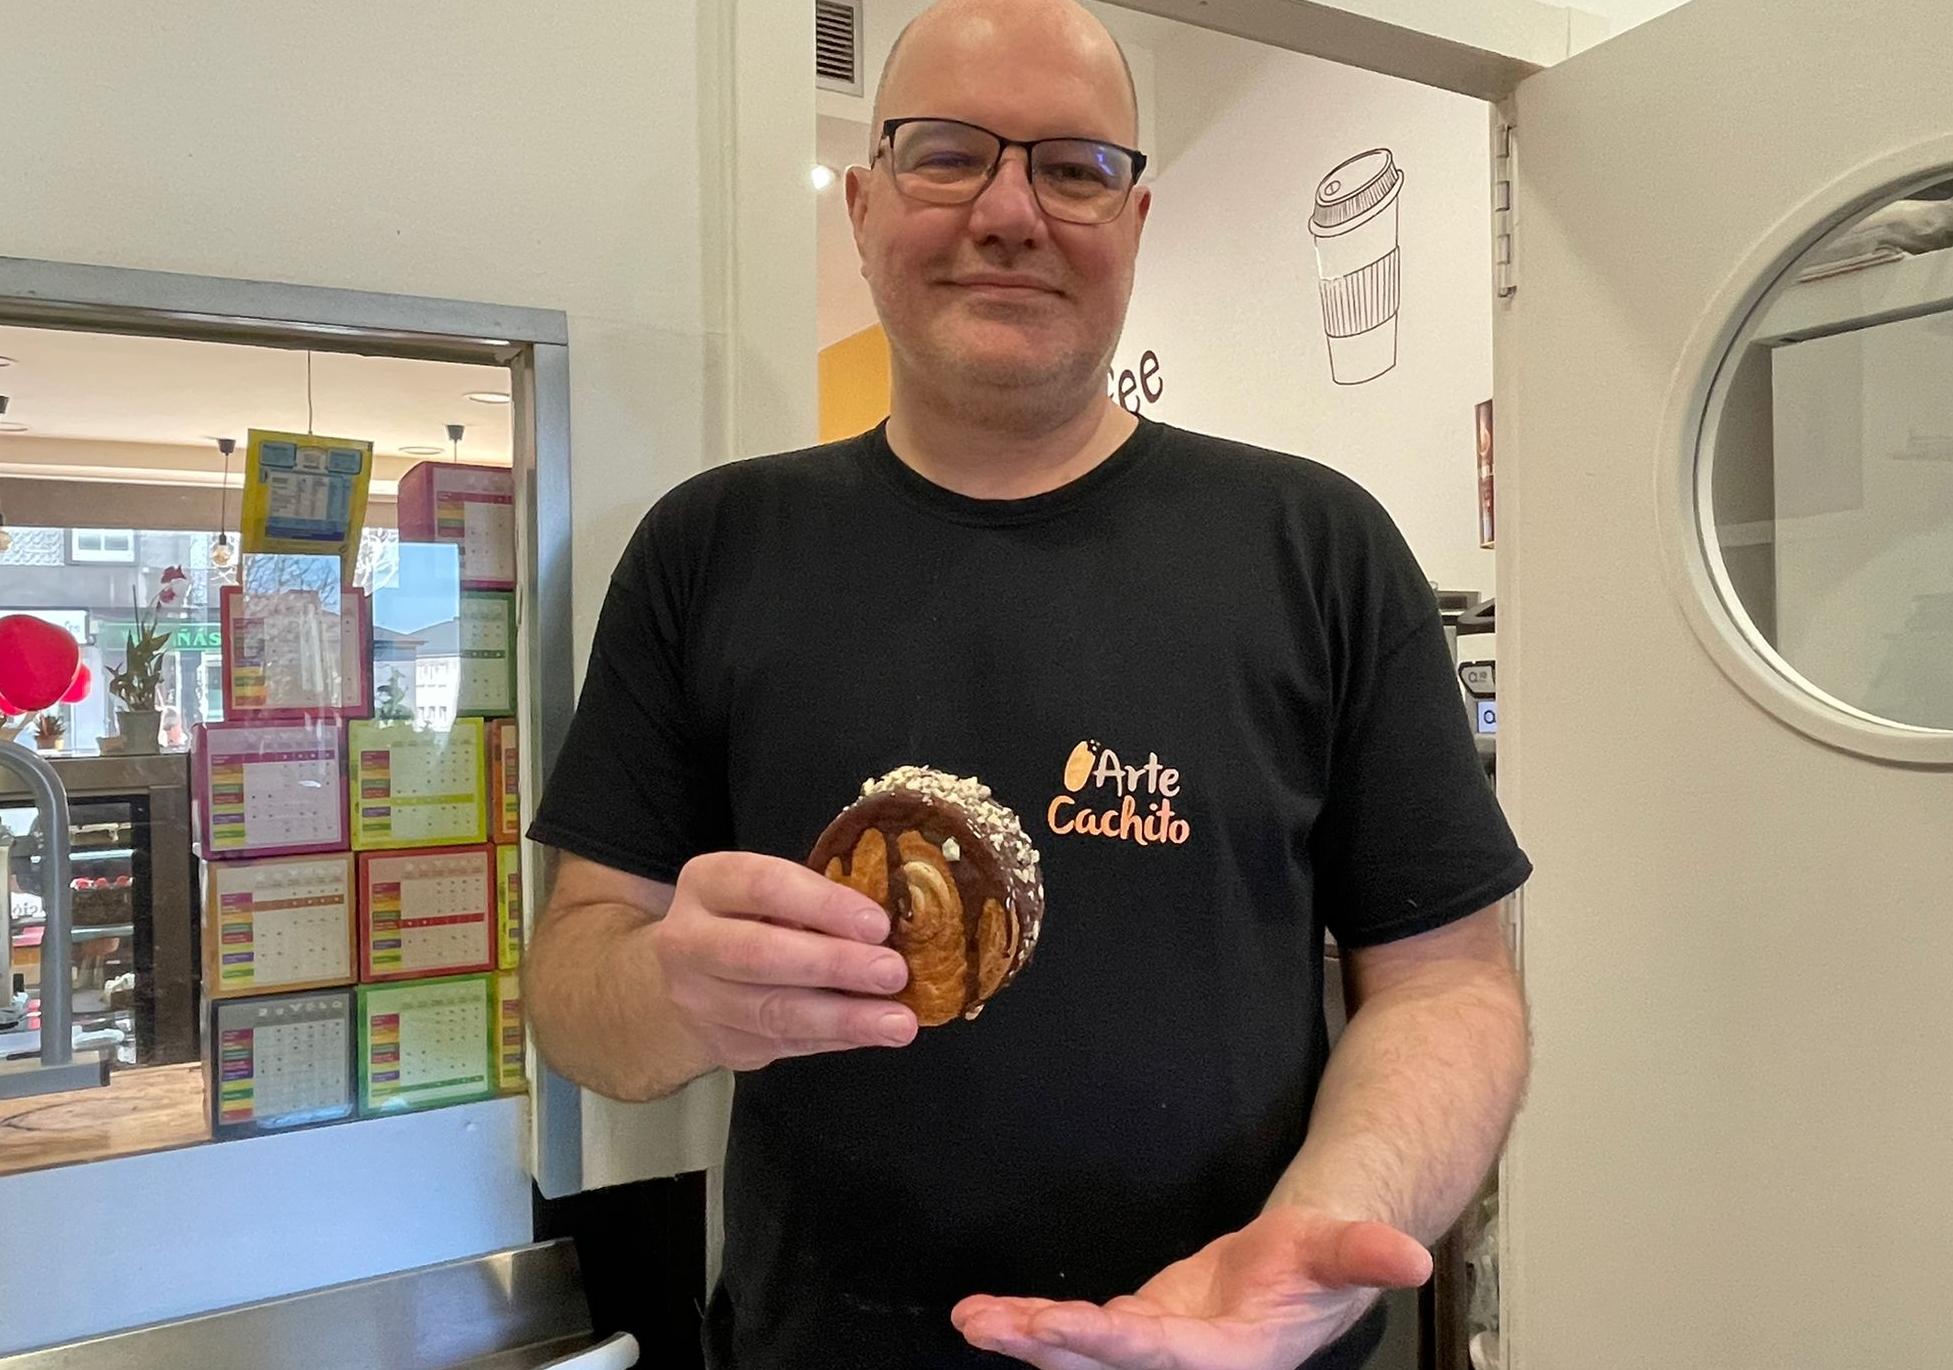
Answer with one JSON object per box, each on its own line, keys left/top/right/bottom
{"left": 0, "top": 0, "right": 816, "bottom": 1350}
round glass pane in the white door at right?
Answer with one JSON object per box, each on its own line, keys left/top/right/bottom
{"left": 1695, "top": 180, "right": 1953, "bottom": 733}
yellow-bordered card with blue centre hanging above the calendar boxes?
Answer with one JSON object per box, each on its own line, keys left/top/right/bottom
{"left": 238, "top": 428, "right": 373, "bottom": 578}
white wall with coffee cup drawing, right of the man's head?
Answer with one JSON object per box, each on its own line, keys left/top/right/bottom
{"left": 1115, "top": 25, "right": 1492, "bottom": 594}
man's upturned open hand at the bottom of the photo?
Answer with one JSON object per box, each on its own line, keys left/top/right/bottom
{"left": 951, "top": 1206, "right": 1432, "bottom": 1370}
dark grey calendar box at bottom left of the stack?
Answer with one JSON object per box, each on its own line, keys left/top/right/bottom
{"left": 205, "top": 989, "right": 353, "bottom": 1137}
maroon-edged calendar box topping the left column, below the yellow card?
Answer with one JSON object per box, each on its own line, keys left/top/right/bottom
{"left": 219, "top": 584, "right": 373, "bottom": 721}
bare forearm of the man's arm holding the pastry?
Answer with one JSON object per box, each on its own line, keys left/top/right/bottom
{"left": 523, "top": 905, "right": 711, "bottom": 1100}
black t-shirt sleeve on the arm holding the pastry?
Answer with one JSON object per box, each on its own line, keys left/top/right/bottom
{"left": 529, "top": 502, "right": 730, "bottom": 881}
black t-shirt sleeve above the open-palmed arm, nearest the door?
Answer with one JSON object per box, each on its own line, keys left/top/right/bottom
{"left": 1310, "top": 510, "right": 1533, "bottom": 946}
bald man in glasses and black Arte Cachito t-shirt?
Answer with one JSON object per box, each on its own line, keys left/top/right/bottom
{"left": 525, "top": 0, "right": 1529, "bottom": 1370}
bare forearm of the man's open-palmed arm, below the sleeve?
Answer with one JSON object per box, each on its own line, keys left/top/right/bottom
{"left": 1269, "top": 965, "right": 1527, "bottom": 1243}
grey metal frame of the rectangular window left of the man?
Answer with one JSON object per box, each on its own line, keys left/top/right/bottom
{"left": 0, "top": 256, "right": 584, "bottom": 1196}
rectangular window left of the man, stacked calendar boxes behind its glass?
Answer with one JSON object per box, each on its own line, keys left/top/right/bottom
{"left": 0, "top": 330, "right": 525, "bottom": 1173}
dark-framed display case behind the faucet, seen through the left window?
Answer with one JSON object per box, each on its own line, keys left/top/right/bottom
{"left": 0, "top": 752, "right": 201, "bottom": 1067}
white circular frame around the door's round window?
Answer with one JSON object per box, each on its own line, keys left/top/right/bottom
{"left": 1654, "top": 133, "right": 1953, "bottom": 766}
